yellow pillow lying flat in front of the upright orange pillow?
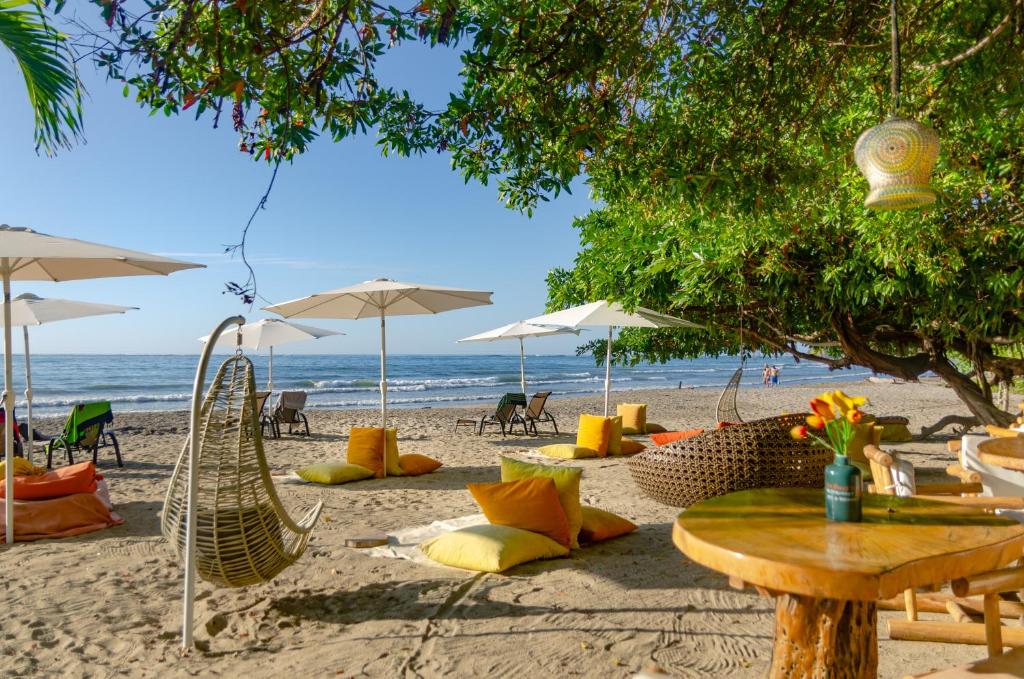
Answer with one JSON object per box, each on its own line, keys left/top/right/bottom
{"left": 420, "top": 523, "right": 569, "bottom": 572}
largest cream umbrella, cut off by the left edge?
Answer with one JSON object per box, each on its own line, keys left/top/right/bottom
{"left": 0, "top": 224, "right": 203, "bottom": 545}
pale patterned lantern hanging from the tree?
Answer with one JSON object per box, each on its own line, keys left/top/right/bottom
{"left": 853, "top": 117, "right": 939, "bottom": 210}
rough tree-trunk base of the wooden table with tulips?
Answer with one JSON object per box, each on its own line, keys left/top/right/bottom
{"left": 769, "top": 594, "right": 879, "bottom": 679}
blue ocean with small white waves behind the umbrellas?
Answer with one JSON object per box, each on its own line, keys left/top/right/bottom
{"left": 0, "top": 354, "right": 869, "bottom": 417}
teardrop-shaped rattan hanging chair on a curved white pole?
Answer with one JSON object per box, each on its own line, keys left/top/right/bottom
{"left": 161, "top": 352, "right": 324, "bottom": 587}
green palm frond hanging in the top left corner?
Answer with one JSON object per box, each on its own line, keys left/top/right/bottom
{"left": 0, "top": 0, "right": 82, "bottom": 156}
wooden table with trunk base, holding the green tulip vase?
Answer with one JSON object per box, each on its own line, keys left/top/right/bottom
{"left": 673, "top": 489, "right": 1024, "bottom": 678}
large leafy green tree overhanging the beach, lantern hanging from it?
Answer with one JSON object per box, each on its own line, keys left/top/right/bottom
{"left": 72, "top": 0, "right": 1024, "bottom": 422}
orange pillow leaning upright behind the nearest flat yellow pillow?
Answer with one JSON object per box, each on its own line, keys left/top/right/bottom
{"left": 466, "top": 477, "right": 570, "bottom": 547}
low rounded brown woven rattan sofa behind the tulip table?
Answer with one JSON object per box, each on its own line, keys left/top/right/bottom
{"left": 629, "top": 415, "right": 833, "bottom": 507}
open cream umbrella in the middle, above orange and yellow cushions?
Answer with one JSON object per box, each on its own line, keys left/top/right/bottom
{"left": 264, "top": 279, "right": 494, "bottom": 438}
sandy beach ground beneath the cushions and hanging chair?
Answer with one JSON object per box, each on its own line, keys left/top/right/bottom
{"left": 0, "top": 382, "right": 1003, "bottom": 679}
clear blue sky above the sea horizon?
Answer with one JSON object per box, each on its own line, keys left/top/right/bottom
{"left": 0, "top": 28, "right": 593, "bottom": 353}
